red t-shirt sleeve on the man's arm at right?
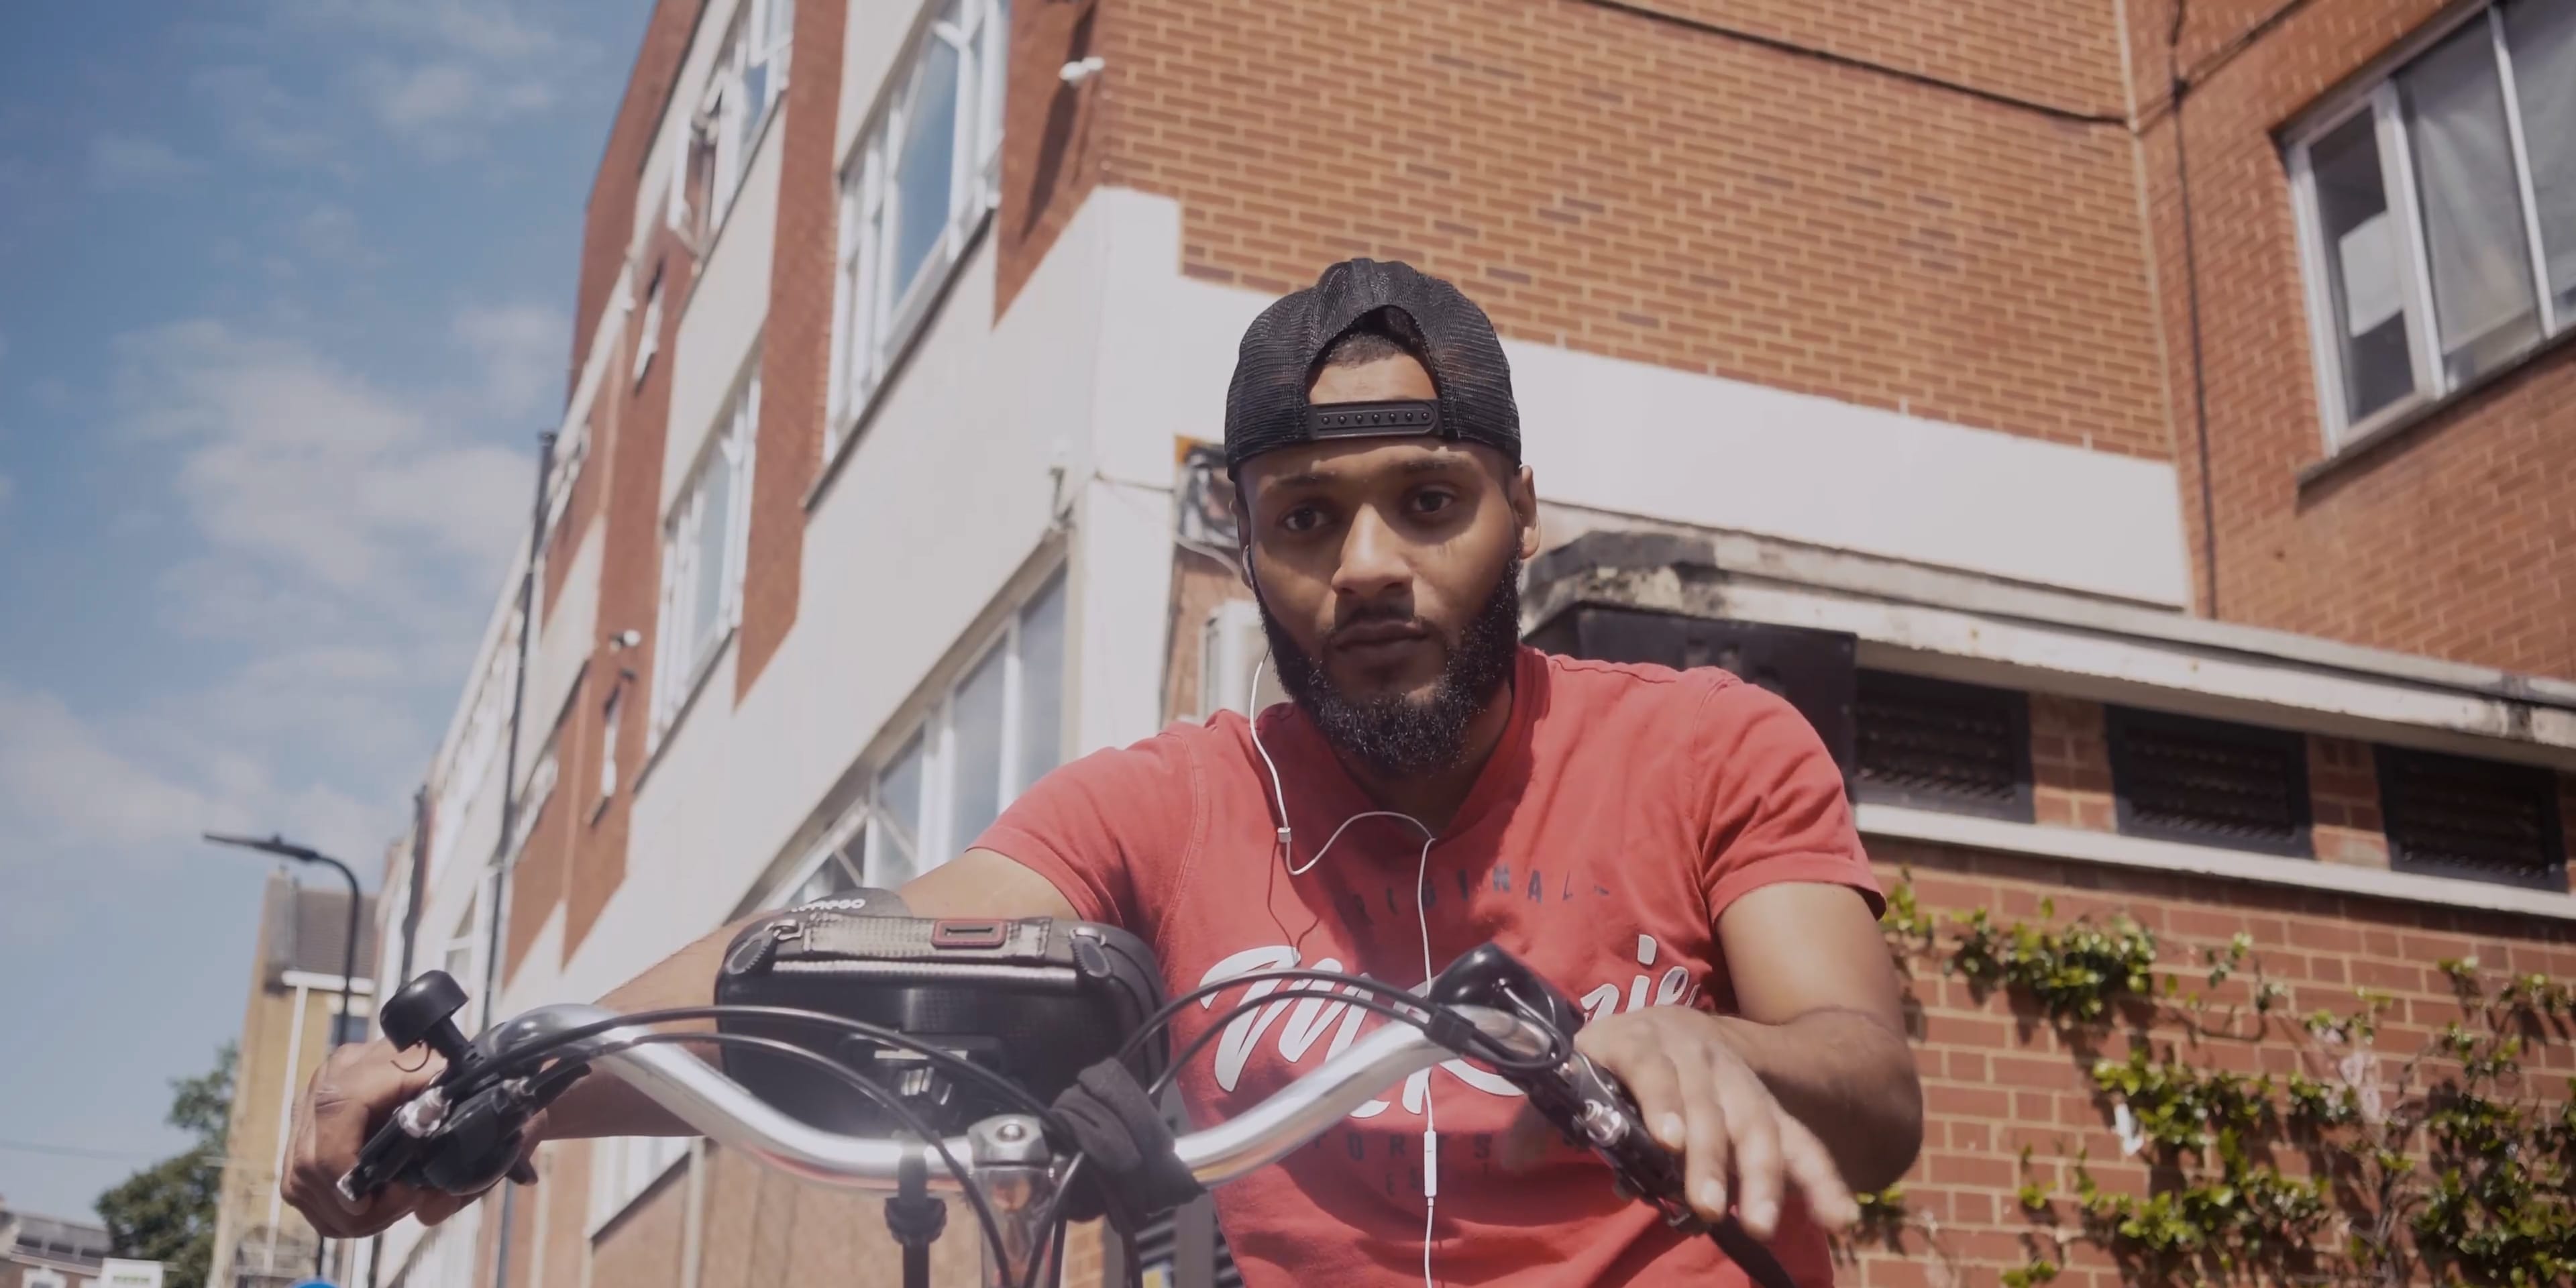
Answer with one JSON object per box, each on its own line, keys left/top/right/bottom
{"left": 1695, "top": 680, "right": 1886, "bottom": 922}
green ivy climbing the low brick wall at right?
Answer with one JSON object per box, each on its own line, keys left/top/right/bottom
{"left": 1862, "top": 883, "right": 2576, "bottom": 1288}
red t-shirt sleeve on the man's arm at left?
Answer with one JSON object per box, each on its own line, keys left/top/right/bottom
{"left": 974, "top": 732, "right": 1200, "bottom": 941}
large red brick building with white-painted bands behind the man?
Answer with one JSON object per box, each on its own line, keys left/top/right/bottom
{"left": 368, "top": 0, "right": 2576, "bottom": 1288}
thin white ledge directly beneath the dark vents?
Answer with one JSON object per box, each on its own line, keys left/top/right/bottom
{"left": 1855, "top": 801, "right": 2576, "bottom": 922}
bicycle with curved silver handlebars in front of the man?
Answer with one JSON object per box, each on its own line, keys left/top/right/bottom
{"left": 340, "top": 899, "right": 1793, "bottom": 1288}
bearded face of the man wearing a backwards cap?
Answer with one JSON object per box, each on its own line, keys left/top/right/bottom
{"left": 1242, "top": 356, "right": 1538, "bottom": 773}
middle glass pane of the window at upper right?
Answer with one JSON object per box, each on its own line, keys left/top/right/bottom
{"left": 2398, "top": 23, "right": 2540, "bottom": 381}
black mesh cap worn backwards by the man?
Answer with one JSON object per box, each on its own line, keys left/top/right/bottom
{"left": 1226, "top": 260, "right": 1520, "bottom": 469}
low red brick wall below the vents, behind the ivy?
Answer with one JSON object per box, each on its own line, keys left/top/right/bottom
{"left": 1844, "top": 843, "right": 2576, "bottom": 1288}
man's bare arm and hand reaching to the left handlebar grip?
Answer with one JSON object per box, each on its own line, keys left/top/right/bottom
{"left": 283, "top": 850, "right": 1074, "bottom": 1239}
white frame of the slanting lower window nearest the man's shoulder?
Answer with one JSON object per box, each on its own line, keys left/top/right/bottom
{"left": 760, "top": 570, "right": 1074, "bottom": 907}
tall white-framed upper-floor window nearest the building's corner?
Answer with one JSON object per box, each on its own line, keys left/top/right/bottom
{"left": 824, "top": 0, "right": 1010, "bottom": 459}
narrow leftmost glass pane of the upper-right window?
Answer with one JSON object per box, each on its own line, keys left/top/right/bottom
{"left": 2308, "top": 111, "right": 2414, "bottom": 423}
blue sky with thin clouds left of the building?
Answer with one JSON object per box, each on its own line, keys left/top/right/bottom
{"left": 0, "top": 0, "right": 652, "bottom": 1216}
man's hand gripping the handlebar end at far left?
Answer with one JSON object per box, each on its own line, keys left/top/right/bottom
{"left": 281, "top": 1038, "right": 486, "bottom": 1239}
